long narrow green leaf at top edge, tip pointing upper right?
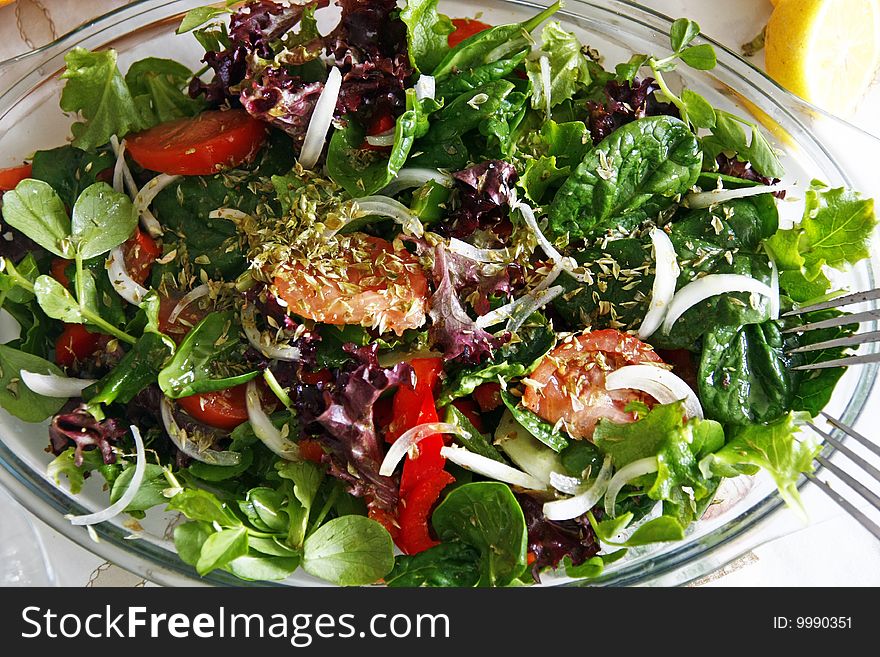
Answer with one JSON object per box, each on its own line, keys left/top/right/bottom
{"left": 434, "top": 2, "right": 561, "bottom": 82}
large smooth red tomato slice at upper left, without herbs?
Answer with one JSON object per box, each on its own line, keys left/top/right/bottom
{"left": 126, "top": 109, "right": 266, "bottom": 176}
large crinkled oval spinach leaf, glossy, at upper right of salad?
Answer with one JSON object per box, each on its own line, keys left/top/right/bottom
{"left": 548, "top": 116, "right": 702, "bottom": 240}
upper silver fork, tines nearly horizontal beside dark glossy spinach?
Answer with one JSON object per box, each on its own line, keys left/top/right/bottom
{"left": 782, "top": 289, "right": 880, "bottom": 370}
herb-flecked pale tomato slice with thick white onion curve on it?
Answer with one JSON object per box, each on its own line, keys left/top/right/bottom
{"left": 522, "top": 329, "right": 663, "bottom": 438}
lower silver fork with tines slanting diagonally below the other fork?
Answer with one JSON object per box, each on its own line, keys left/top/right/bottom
{"left": 806, "top": 412, "right": 880, "bottom": 540}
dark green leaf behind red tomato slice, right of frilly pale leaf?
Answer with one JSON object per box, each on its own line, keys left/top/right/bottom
{"left": 125, "top": 57, "right": 205, "bottom": 125}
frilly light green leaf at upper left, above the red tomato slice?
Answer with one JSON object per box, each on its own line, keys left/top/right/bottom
{"left": 61, "top": 48, "right": 150, "bottom": 150}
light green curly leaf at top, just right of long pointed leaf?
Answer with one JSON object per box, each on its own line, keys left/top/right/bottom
{"left": 526, "top": 22, "right": 592, "bottom": 110}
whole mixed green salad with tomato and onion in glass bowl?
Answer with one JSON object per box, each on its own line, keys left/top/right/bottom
{"left": 0, "top": 0, "right": 876, "bottom": 586}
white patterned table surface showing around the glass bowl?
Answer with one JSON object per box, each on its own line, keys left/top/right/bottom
{"left": 0, "top": 0, "right": 880, "bottom": 586}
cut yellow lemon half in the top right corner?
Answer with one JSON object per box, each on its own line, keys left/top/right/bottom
{"left": 765, "top": 0, "right": 880, "bottom": 115}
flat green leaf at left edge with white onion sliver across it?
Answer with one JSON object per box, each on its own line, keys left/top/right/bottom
{"left": 0, "top": 345, "right": 67, "bottom": 422}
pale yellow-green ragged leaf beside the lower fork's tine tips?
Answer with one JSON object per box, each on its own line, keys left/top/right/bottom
{"left": 700, "top": 413, "right": 821, "bottom": 514}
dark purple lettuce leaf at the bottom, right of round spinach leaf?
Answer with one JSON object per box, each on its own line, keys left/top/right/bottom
{"left": 516, "top": 493, "right": 601, "bottom": 582}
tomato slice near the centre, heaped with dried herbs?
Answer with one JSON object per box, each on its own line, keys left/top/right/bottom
{"left": 275, "top": 233, "right": 428, "bottom": 335}
